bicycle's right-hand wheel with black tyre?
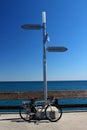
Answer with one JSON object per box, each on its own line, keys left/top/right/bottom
{"left": 45, "top": 105, "right": 62, "bottom": 122}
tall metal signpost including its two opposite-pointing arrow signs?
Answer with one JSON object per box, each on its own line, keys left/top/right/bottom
{"left": 21, "top": 12, "right": 67, "bottom": 102}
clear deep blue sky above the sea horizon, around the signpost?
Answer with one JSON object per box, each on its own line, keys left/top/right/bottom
{"left": 0, "top": 0, "right": 87, "bottom": 81}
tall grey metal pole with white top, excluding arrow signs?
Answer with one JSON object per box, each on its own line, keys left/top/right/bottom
{"left": 42, "top": 12, "right": 47, "bottom": 102}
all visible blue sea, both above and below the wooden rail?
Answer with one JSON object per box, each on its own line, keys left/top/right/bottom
{"left": 0, "top": 81, "right": 87, "bottom": 109}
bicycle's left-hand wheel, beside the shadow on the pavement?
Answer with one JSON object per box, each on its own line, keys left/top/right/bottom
{"left": 19, "top": 106, "right": 36, "bottom": 121}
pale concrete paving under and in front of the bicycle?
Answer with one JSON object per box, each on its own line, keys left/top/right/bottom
{"left": 0, "top": 112, "right": 87, "bottom": 130}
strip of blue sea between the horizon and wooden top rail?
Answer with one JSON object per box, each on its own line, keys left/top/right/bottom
{"left": 0, "top": 81, "right": 87, "bottom": 91}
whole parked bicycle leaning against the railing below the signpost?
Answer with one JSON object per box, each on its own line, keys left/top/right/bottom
{"left": 19, "top": 98, "right": 62, "bottom": 122}
